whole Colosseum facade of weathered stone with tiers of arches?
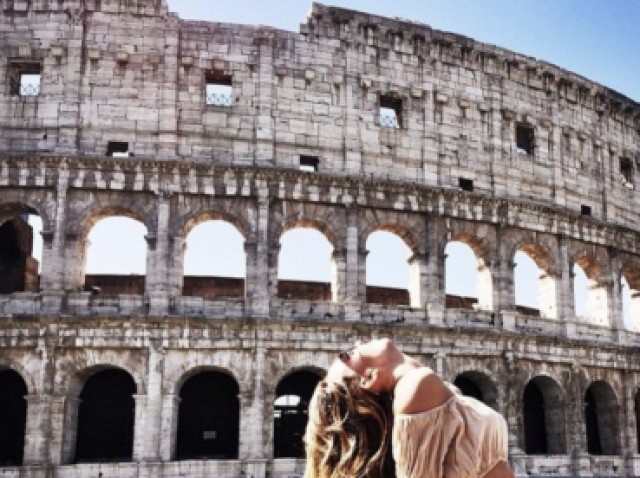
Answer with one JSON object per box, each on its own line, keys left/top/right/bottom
{"left": 0, "top": 0, "right": 640, "bottom": 478}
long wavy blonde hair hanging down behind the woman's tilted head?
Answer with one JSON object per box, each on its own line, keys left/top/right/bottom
{"left": 304, "top": 377, "right": 395, "bottom": 478}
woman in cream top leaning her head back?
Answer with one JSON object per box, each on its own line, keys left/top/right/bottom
{"left": 305, "top": 339, "right": 513, "bottom": 478}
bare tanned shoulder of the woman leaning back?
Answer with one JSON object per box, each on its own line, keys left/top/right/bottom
{"left": 393, "top": 367, "right": 453, "bottom": 415}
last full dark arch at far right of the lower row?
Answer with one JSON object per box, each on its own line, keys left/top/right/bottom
{"left": 584, "top": 381, "right": 620, "bottom": 455}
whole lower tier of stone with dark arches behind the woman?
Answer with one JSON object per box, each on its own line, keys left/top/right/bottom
{"left": 0, "top": 317, "right": 640, "bottom": 478}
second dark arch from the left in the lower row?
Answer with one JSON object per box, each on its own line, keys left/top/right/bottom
{"left": 75, "top": 369, "right": 136, "bottom": 463}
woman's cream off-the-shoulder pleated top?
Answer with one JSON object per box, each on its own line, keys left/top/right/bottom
{"left": 393, "top": 394, "right": 508, "bottom": 478}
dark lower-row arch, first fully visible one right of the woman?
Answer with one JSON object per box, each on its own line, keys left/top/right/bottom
{"left": 522, "top": 377, "right": 566, "bottom": 455}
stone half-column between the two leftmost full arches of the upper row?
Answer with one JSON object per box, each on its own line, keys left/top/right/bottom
{"left": 145, "top": 191, "right": 175, "bottom": 316}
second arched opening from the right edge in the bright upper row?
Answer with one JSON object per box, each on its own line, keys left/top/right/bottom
{"left": 573, "top": 258, "right": 609, "bottom": 325}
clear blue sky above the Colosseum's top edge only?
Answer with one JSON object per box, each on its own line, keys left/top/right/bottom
{"left": 168, "top": 0, "right": 640, "bottom": 101}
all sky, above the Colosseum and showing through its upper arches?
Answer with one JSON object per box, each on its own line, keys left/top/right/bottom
{"left": 25, "top": 0, "right": 640, "bottom": 328}
